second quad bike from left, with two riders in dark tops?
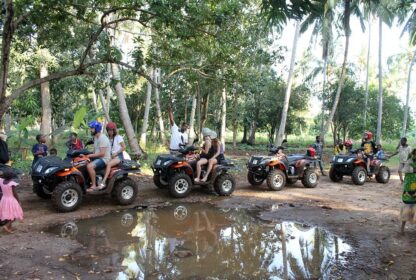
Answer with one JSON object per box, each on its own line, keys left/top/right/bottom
{"left": 152, "top": 145, "right": 237, "bottom": 198}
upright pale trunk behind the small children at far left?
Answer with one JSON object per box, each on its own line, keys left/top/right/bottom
{"left": 40, "top": 65, "right": 52, "bottom": 142}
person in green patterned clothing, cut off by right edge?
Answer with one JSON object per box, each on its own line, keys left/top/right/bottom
{"left": 400, "top": 149, "right": 416, "bottom": 234}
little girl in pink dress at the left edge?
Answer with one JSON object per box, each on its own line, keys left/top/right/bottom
{"left": 0, "top": 170, "right": 23, "bottom": 233}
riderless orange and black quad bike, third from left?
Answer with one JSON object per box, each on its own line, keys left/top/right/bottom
{"left": 247, "top": 146, "right": 319, "bottom": 191}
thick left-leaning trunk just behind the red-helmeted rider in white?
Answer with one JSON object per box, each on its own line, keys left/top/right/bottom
{"left": 111, "top": 64, "right": 143, "bottom": 158}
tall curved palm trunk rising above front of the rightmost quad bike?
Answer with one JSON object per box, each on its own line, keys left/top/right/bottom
{"left": 321, "top": 0, "right": 351, "bottom": 139}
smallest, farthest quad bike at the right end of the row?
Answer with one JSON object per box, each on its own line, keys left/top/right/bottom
{"left": 329, "top": 149, "right": 390, "bottom": 185}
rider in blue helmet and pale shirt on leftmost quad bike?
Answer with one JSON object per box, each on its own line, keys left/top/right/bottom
{"left": 87, "top": 121, "right": 111, "bottom": 191}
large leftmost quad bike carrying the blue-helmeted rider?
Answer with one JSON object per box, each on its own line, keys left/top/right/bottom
{"left": 32, "top": 150, "right": 140, "bottom": 212}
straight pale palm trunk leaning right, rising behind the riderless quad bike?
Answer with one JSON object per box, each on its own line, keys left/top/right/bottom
{"left": 275, "top": 21, "right": 300, "bottom": 146}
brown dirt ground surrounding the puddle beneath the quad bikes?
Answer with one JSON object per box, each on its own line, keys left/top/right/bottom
{"left": 0, "top": 161, "right": 416, "bottom": 280}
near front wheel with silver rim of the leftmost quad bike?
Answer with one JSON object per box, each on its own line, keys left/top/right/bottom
{"left": 52, "top": 181, "right": 82, "bottom": 212}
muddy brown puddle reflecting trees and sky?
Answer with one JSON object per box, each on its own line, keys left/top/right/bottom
{"left": 52, "top": 204, "right": 350, "bottom": 279}
